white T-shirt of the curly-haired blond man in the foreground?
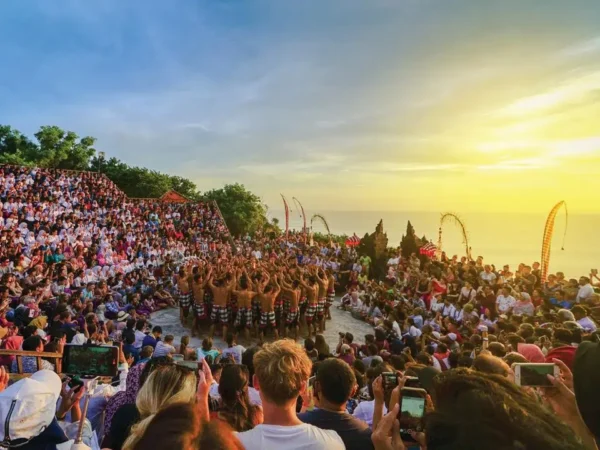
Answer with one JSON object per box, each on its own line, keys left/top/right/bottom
{"left": 237, "top": 423, "right": 346, "bottom": 450}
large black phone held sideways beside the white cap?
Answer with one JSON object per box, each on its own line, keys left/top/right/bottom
{"left": 63, "top": 344, "right": 119, "bottom": 377}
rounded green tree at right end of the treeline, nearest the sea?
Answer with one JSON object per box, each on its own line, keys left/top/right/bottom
{"left": 204, "top": 183, "right": 267, "bottom": 235}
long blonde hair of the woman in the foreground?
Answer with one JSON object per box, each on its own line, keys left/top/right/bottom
{"left": 123, "top": 365, "right": 196, "bottom": 450}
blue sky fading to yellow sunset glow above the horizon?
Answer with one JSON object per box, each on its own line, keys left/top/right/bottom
{"left": 0, "top": 0, "right": 600, "bottom": 213}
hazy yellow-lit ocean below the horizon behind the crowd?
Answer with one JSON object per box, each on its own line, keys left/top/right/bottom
{"left": 269, "top": 210, "right": 600, "bottom": 278}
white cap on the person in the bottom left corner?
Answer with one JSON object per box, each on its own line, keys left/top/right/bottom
{"left": 0, "top": 370, "right": 61, "bottom": 446}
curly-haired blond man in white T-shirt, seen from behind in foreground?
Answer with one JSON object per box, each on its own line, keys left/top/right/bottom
{"left": 237, "top": 340, "right": 345, "bottom": 450}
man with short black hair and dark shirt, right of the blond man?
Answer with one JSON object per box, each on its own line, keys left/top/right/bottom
{"left": 298, "top": 358, "right": 373, "bottom": 450}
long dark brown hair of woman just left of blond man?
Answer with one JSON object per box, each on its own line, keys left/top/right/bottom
{"left": 213, "top": 364, "right": 263, "bottom": 432}
